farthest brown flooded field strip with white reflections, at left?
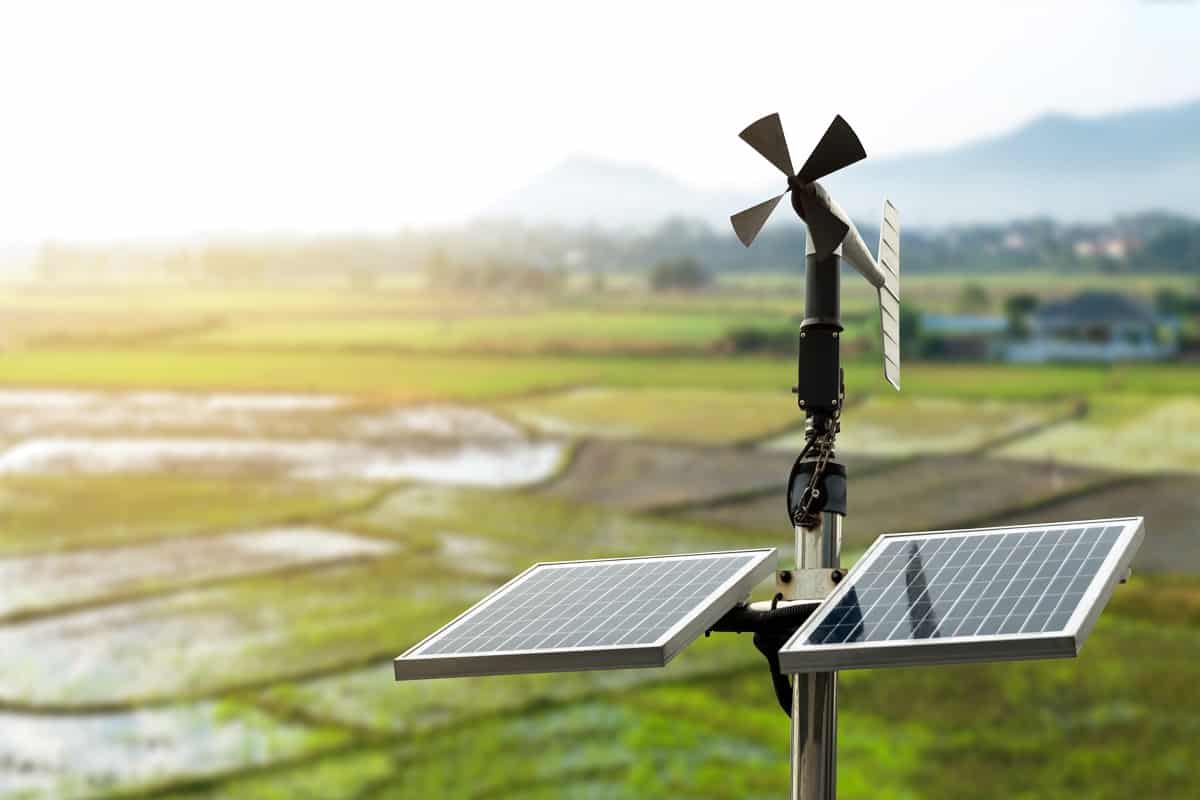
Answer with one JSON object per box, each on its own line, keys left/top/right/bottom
{"left": 0, "top": 390, "right": 564, "bottom": 487}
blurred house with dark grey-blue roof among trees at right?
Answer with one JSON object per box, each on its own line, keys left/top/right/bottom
{"left": 1006, "top": 290, "right": 1178, "bottom": 362}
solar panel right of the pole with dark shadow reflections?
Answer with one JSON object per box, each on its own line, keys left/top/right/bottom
{"left": 779, "top": 517, "right": 1145, "bottom": 673}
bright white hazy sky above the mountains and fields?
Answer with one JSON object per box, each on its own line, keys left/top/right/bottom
{"left": 0, "top": 0, "right": 1200, "bottom": 242}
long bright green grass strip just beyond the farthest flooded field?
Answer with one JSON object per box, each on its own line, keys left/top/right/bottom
{"left": 7, "top": 348, "right": 1200, "bottom": 402}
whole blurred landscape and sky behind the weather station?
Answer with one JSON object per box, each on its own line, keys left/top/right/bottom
{"left": 0, "top": 1, "right": 1200, "bottom": 800}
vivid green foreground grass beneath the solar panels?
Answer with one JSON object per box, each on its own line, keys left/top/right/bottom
{"left": 166, "top": 599, "right": 1200, "bottom": 799}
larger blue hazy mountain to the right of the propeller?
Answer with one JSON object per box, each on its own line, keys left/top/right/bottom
{"left": 828, "top": 101, "right": 1200, "bottom": 224}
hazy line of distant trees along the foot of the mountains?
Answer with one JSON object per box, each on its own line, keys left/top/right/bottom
{"left": 35, "top": 212, "right": 1200, "bottom": 290}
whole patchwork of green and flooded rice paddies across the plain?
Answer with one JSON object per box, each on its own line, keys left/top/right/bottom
{"left": 0, "top": 277, "right": 1200, "bottom": 800}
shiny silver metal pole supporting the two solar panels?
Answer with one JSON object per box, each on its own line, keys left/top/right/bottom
{"left": 792, "top": 511, "right": 842, "bottom": 800}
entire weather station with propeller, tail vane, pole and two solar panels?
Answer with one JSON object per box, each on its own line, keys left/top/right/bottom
{"left": 395, "top": 114, "right": 1145, "bottom": 800}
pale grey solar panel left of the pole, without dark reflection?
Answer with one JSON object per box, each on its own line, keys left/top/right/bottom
{"left": 395, "top": 548, "right": 775, "bottom": 680}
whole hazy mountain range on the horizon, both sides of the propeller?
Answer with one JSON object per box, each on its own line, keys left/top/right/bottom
{"left": 485, "top": 101, "right": 1200, "bottom": 227}
